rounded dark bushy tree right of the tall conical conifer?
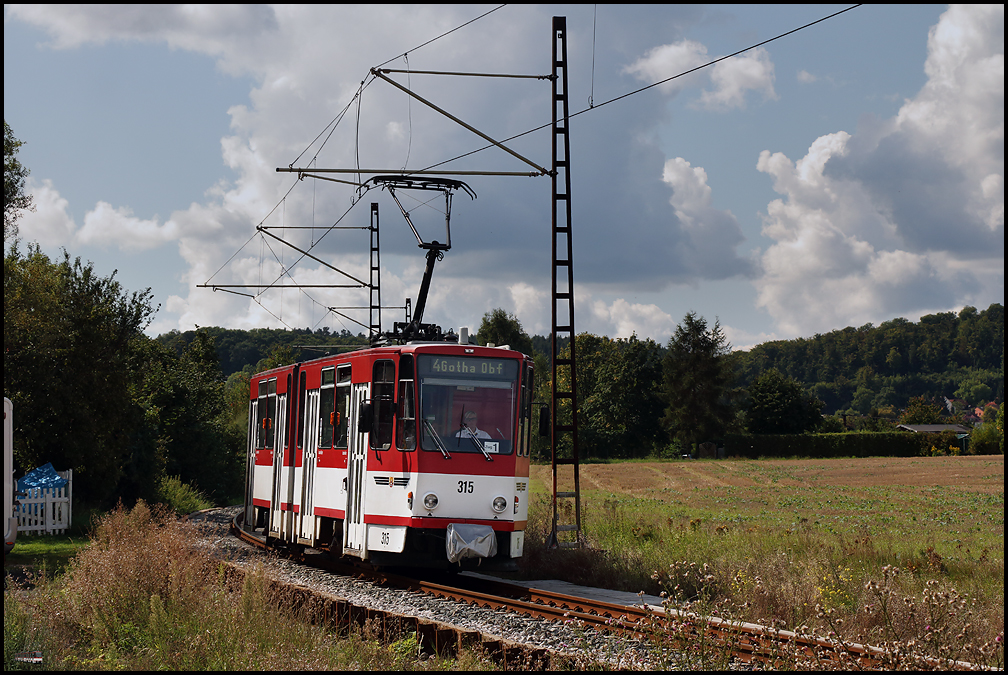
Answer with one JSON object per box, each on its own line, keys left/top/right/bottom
{"left": 746, "top": 369, "right": 823, "bottom": 433}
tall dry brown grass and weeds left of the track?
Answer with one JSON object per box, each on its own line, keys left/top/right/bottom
{"left": 4, "top": 503, "right": 493, "bottom": 670}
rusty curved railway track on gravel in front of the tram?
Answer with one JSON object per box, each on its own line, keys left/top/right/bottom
{"left": 231, "top": 514, "right": 973, "bottom": 670}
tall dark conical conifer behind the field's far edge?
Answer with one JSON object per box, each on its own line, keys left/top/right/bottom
{"left": 661, "top": 311, "right": 735, "bottom": 446}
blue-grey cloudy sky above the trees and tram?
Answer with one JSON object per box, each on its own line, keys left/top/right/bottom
{"left": 4, "top": 5, "right": 1004, "bottom": 349}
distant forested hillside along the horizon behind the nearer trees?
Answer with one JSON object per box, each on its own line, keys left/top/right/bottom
{"left": 157, "top": 304, "right": 1005, "bottom": 425}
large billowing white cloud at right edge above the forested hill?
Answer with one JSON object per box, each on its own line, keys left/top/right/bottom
{"left": 754, "top": 6, "right": 1004, "bottom": 334}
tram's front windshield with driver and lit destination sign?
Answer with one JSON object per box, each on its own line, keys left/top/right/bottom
{"left": 416, "top": 355, "right": 518, "bottom": 454}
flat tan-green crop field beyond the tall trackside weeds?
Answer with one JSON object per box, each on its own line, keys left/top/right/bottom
{"left": 532, "top": 455, "right": 1004, "bottom": 560}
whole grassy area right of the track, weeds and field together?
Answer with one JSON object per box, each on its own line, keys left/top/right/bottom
{"left": 523, "top": 455, "right": 1004, "bottom": 663}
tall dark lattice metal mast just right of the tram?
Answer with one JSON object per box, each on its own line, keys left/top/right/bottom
{"left": 547, "top": 16, "right": 582, "bottom": 548}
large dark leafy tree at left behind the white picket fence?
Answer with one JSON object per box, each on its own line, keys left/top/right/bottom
{"left": 3, "top": 241, "right": 154, "bottom": 501}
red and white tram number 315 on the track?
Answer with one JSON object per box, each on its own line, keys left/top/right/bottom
{"left": 244, "top": 338, "right": 532, "bottom": 568}
